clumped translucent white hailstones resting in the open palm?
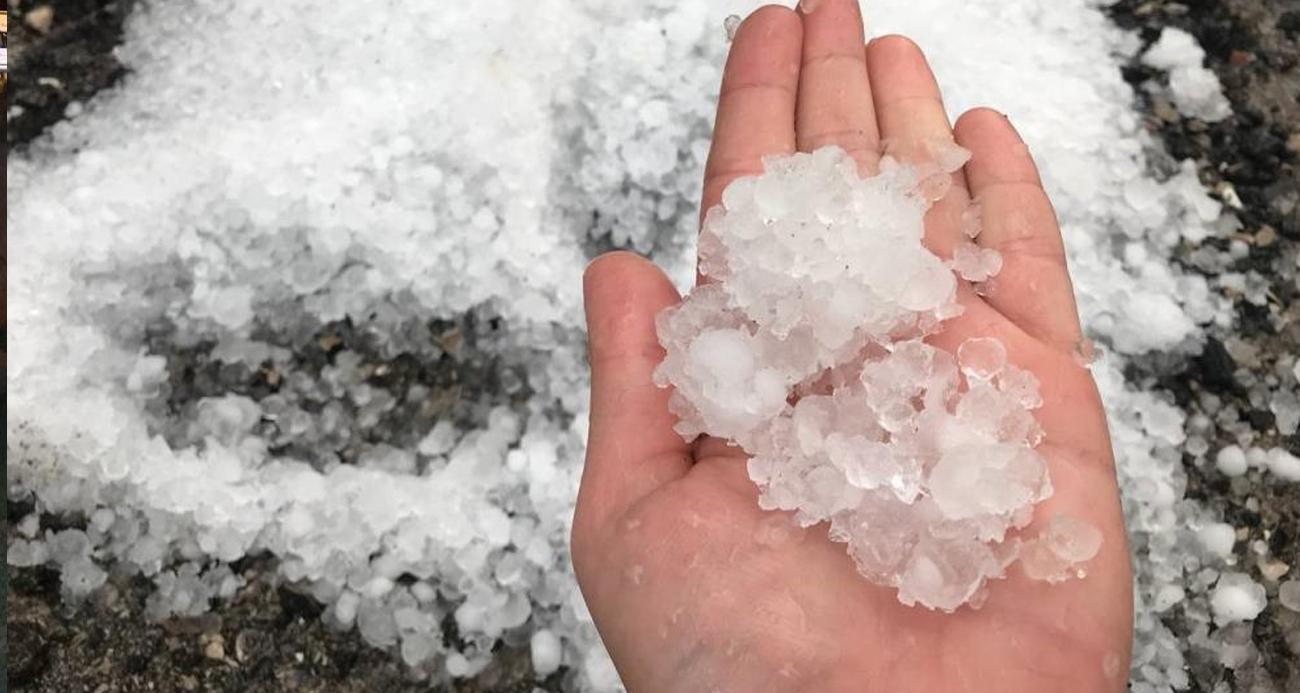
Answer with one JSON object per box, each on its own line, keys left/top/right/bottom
{"left": 655, "top": 142, "right": 1101, "bottom": 611}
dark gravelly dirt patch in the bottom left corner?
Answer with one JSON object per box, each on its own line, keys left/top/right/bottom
{"left": 7, "top": 548, "right": 560, "bottom": 693}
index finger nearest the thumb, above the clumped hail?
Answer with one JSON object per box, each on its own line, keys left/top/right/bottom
{"left": 699, "top": 5, "right": 803, "bottom": 221}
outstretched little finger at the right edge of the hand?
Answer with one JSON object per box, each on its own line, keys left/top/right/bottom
{"left": 957, "top": 108, "right": 1080, "bottom": 350}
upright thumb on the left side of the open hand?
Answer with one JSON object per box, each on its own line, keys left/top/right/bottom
{"left": 575, "top": 252, "right": 690, "bottom": 533}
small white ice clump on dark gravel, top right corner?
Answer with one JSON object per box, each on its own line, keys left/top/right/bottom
{"left": 1141, "top": 26, "right": 1232, "bottom": 122}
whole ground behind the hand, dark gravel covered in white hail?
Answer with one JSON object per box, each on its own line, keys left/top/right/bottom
{"left": 7, "top": 0, "right": 1300, "bottom": 692}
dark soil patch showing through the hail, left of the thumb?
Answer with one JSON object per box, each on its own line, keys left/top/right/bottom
{"left": 144, "top": 311, "right": 532, "bottom": 468}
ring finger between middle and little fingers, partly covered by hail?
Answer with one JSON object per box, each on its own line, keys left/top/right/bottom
{"left": 866, "top": 36, "right": 969, "bottom": 257}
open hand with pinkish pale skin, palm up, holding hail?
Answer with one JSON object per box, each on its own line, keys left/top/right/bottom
{"left": 572, "top": 0, "right": 1132, "bottom": 693}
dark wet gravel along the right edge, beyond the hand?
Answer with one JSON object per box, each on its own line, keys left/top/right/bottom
{"left": 1112, "top": 0, "right": 1300, "bottom": 693}
